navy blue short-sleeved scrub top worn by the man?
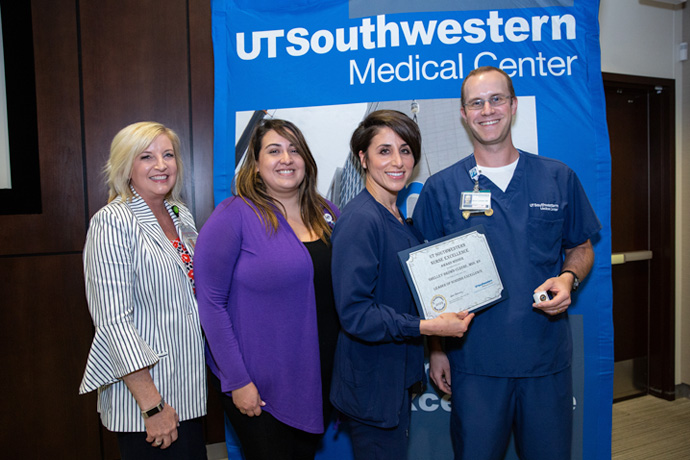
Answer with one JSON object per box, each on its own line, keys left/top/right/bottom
{"left": 414, "top": 151, "right": 601, "bottom": 377}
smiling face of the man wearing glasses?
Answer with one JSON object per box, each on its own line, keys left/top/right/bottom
{"left": 460, "top": 71, "right": 517, "bottom": 147}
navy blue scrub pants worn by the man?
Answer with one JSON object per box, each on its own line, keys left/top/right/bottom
{"left": 450, "top": 367, "right": 573, "bottom": 460}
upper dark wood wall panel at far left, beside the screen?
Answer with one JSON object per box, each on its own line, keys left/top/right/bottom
{"left": 0, "top": 0, "right": 85, "bottom": 255}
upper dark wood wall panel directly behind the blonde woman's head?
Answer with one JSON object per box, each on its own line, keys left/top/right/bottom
{"left": 80, "top": 0, "right": 190, "bottom": 216}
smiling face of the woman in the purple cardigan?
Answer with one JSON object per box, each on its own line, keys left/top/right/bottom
{"left": 256, "top": 130, "right": 305, "bottom": 200}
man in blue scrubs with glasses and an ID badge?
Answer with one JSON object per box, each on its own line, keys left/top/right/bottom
{"left": 414, "top": 67, "right": 601, "bottom": 460}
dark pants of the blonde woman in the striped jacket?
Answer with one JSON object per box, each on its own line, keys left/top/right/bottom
{"left": 116, "top": 418, "right": 208, "bottom": 460}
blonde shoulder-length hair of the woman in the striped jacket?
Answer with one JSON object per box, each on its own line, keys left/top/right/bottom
{"left": 103, "top": 121, "right": 183, "bottom": 203}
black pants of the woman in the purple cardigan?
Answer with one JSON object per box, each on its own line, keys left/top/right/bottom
{"left": 210, "top": 374, "right": 322, "bottom": 460}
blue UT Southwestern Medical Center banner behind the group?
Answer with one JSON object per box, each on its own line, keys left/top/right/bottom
{"left": 212, "top": 0, "right": 613, "bottom": 459}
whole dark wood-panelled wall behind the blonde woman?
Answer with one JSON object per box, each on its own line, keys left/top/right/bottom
{"left": 0, "top": 0, "right": 223, "bottom": 459}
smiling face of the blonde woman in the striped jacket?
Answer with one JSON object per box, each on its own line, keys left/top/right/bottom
{"left": 130, "top": 134, "right": 177, "bottom": 203}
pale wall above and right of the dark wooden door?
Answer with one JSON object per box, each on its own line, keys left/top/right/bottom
{"left": 599, "top": 0, "right": 690, "bottom": 384}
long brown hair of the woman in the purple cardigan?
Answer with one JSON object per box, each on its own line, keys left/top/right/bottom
{"left": 235, "top": 119, "right": 335, "bottom": 241}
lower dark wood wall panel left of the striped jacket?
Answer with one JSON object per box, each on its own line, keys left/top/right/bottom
{"left": 0, "top": 254, "right": 100, "bottom": 459}
